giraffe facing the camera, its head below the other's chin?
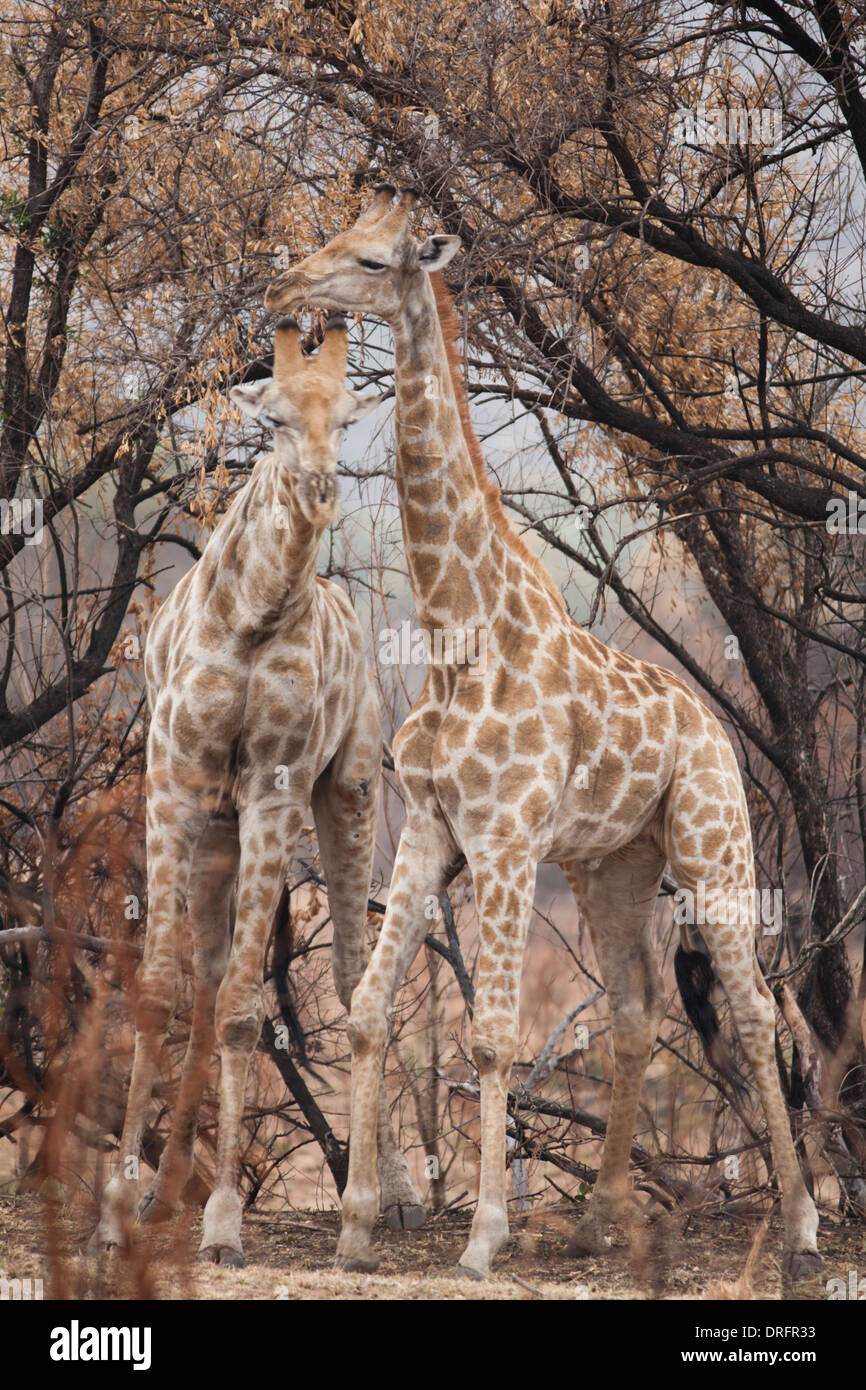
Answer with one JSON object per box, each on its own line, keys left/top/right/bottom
{"left": 92, "top": 318, "right": 425, "bottom": 1268}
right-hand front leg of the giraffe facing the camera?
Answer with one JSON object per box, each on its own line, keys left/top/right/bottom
{"left": 199, "top": 798, "right": 306, "bottom": 1269}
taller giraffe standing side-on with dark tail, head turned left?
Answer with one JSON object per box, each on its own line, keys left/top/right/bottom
{"left": 265, "top": 185, "right": 819, "bottom": 1276}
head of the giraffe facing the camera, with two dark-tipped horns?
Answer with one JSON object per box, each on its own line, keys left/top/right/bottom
{"left": 229, "top": 316, "right": 381, "bottom": 528}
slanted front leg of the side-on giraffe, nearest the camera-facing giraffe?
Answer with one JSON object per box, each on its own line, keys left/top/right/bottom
{"left": 336, "top": 823, "right": 455, "bottom": 1270}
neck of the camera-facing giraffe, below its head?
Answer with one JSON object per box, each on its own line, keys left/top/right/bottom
{"left": 206, "top": 455, "right": 321, "bottom": 635}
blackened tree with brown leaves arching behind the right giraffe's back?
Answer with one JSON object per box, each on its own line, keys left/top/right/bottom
{"left": 226, "top": 0, "right": 866, "bottom": 1104}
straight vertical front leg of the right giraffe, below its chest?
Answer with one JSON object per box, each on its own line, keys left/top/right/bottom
{"left": 457, "top": 847, "right": 537, "bottom": 1279}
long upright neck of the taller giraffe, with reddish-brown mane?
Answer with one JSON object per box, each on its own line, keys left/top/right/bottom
{"left": 392, "top": 275, "right": 505, "bottom": 630}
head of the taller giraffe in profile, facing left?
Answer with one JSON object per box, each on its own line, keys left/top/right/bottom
{"left": 264, "top": 183, "right": 460, "bottom": 322}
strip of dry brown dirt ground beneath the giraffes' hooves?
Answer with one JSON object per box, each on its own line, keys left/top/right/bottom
{"left": 0, "top": 1195, "right": 866, "bottom": 1301}
